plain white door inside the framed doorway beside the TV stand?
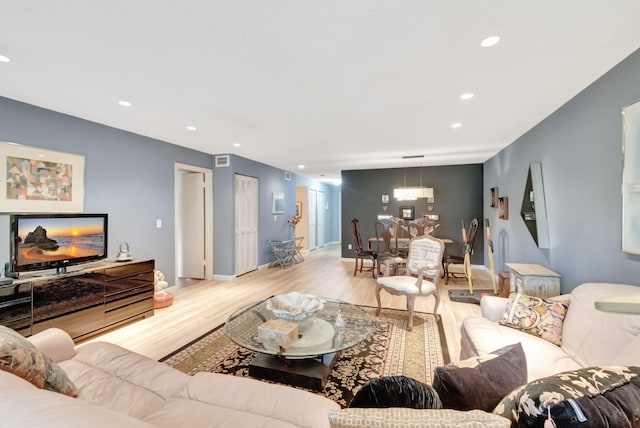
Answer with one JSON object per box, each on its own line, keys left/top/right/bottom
{"left": 178, "top": 171, "right": 205, "bottom": 279}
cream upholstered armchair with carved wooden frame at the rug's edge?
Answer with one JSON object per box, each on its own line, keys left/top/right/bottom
{"left": 376, "top": 235, "right": 444, "bottom": 331}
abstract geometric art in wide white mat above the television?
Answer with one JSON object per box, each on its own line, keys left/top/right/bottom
{"left": 0, "top": 142, "right": 84, "bottom": 213}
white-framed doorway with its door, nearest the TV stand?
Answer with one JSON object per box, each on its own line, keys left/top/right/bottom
{"left": 174, "top": 163, "right": 213, "bottom": 284}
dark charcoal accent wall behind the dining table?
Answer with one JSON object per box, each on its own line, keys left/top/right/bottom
{"left": 342, "top": 164, "right": 485, "bottom": 264}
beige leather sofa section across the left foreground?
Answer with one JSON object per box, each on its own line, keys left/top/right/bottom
{"left": 0, "top": 329, "right": 339, "bottom": 428}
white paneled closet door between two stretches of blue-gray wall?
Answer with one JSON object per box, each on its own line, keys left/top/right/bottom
{"left": 235, "top": 174, "right": 258, "bottom": 275}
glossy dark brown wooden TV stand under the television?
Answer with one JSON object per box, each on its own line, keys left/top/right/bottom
{"left": 0, "top": 260, "right": 155, "bottom": 341}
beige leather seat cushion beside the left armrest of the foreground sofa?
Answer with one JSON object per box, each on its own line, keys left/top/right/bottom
{"left": 60, "top": 342, "right": 190, "bottom": 418}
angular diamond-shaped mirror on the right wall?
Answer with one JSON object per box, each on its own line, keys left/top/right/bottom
{"left": 520, "top": 163, "right": 551, "bottom": 249}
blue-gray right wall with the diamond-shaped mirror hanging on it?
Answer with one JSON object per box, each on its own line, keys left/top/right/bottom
{"left": 484, "top": 51, "right": 640, "bottom": 292}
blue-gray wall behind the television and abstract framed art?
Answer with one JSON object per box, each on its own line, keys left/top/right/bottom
{"left": 0, "top": 97, "right": 211, "bottom": 278}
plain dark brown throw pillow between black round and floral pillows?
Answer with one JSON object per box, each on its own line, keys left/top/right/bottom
{"left": 433, "top": 343, "right": 527, "bottom": 412}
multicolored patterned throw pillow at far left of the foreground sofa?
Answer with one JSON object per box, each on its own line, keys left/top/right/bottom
{"left": 0, "top": 325, "right": 78, "bottom": 397}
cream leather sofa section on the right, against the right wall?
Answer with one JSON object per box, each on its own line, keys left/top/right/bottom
{"left": 460, "top": 283, "right": 640, "bottom": 381}
